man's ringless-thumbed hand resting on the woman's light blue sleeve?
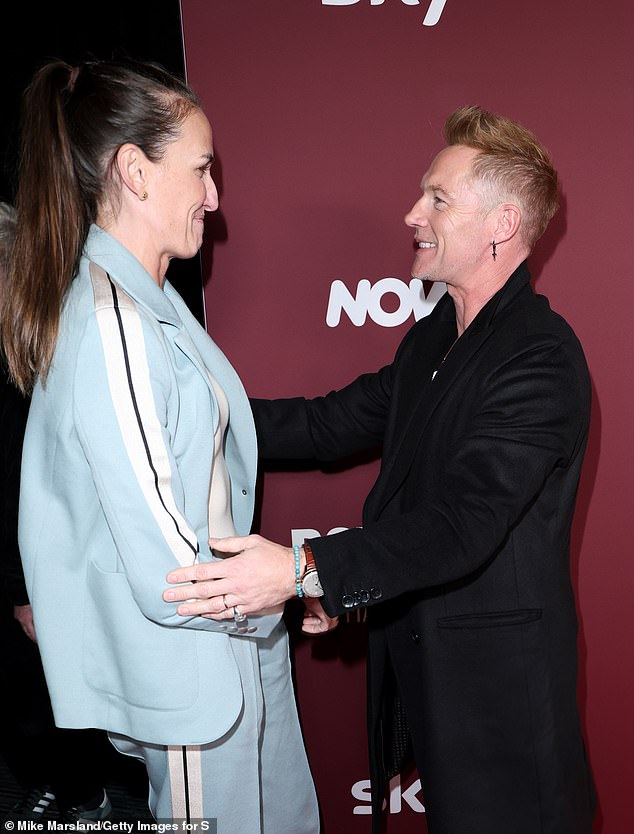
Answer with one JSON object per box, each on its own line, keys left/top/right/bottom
{"left": 163, "top": 536, "right": 303, "bottom": 620}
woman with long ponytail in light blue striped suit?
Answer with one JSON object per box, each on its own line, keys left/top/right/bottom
{"left": 2, "top": 61, "right": 318, "bottom": 834}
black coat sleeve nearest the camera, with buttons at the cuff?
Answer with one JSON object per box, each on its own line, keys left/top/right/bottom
{"left": 311, "top": 338, "right": 589, "bottom": 615}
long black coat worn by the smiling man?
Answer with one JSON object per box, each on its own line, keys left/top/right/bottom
{"left": 253, "top": 263, "right": 593, "bottom": 834}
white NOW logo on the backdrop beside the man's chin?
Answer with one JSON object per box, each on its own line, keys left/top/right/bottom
{"left": 326, "top": 278, "right": 446, "bottom": 327}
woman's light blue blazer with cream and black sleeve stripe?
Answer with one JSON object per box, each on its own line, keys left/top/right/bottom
{"left": 19, "top": 226, "right": 280, "bottom": 745}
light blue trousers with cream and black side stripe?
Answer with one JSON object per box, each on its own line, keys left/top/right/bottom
{"left": 110, "top": 623, "right": 319, "bottom": 834}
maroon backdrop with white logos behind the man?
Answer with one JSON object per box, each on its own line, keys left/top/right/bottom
{"left": 182, "top": 0, "right": 634, "bottom": 834}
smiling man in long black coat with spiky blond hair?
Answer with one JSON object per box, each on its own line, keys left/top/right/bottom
{"left": 166, "top": 107, "right": 593, "bottom": 834}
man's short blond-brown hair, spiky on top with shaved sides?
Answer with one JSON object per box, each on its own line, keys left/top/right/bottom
{"left": 444, "top": 105, "right": 559, "bottom": 249}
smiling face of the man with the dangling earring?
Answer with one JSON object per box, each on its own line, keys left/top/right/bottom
{"left": 405, "top": 145, "right": 491, "bottom": 286}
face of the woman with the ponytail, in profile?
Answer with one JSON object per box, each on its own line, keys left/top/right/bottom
{"left": 144, "top": 110, "right": 218, "bottom": 269}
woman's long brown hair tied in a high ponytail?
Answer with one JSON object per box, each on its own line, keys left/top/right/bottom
{"left": 0, "top": 60, "right": 200, "bottom": 393}
